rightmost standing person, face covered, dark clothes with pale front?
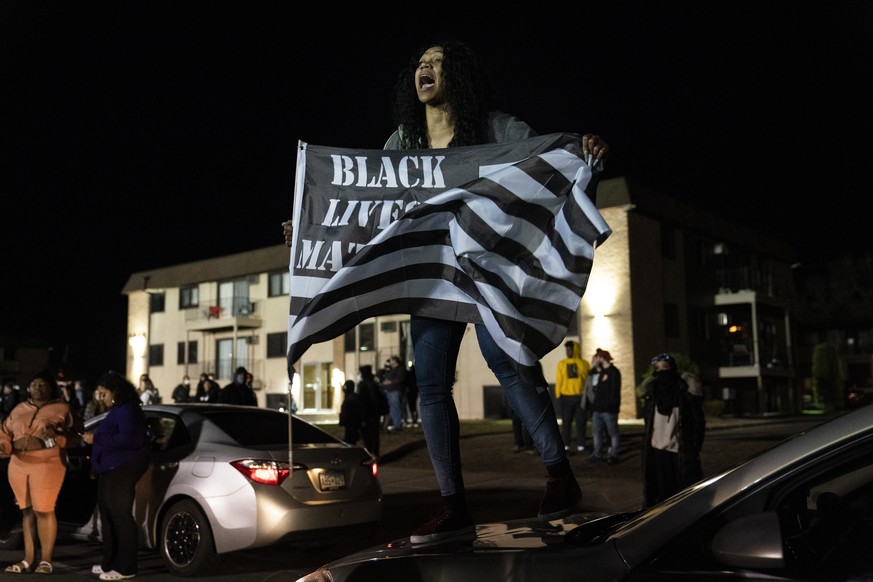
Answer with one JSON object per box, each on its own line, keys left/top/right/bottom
{"left": 642, "top": 353, "right": 706, "bottom": 507}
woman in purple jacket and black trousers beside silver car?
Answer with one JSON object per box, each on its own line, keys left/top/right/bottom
{"left": 82, "top": 372, "right": 151, "bottom": 580}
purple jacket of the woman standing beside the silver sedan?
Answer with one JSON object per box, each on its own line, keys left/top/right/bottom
{"left": 91, "top": 400, "right": 151, "bottom": 474}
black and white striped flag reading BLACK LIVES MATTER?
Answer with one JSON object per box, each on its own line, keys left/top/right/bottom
{"left": 287, "top": 134, "right": 612, "bottom": 377}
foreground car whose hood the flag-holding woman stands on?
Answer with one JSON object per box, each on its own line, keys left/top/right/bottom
{"left": 298, "top": 406, "right": 873, "bottom": 582}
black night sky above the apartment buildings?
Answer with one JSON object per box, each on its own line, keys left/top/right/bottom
{"left": 0, "top": 1, "right": 873, "bottom": 384}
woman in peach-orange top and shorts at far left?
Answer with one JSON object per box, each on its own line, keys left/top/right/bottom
{"left": 0, "top": 372, "right": 76, "bottom": 574}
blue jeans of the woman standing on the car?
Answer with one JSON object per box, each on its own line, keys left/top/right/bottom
{"left": 411, "top": 316, "right": 566, "bottom": 496}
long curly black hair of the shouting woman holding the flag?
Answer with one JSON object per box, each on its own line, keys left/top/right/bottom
{"left": 392, "top": 40, "right": 498, "bottom": 149}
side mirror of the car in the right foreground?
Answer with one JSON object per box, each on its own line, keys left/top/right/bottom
{"left": 710, "top": 511, "right": 785, "bottom": 568}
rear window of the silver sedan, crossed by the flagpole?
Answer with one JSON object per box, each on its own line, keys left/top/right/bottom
{"left": 204, "top": 409, "right": 337, "bottom": 447}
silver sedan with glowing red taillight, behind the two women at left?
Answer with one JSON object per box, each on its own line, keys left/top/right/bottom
{"left": 0, "top": 404, "right": 382, "bottom": 576}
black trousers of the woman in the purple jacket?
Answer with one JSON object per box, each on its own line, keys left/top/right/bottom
{"left": 97, "top": 456, "right": 149, "bottom": 575}
